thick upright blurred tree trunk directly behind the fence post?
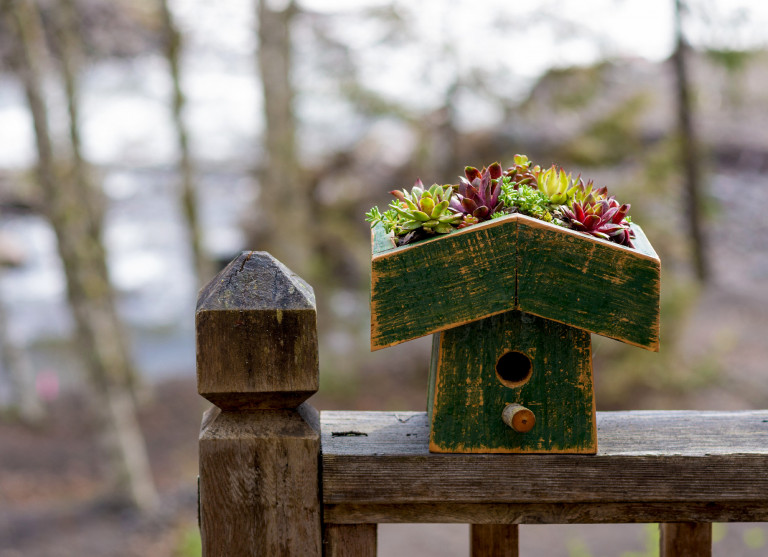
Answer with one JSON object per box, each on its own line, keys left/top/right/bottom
{"left": 250, "top": 0, "right": 314, "bottom": 278}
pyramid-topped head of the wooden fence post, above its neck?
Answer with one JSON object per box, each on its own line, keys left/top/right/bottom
{"left": 196, "top": 252, "right": 318, "bottom": 409}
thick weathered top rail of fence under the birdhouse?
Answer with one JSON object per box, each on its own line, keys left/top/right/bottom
{"left": 322, "top": 411, "right": 768, "bottom": 505}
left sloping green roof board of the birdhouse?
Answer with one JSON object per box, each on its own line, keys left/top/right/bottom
{"left": 371, "top": 217, "right": 517, "bottom": 350}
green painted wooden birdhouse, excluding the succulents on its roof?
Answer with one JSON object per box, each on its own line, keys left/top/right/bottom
{"left": 371, "top": 214, "right": 660, "bottom": 453}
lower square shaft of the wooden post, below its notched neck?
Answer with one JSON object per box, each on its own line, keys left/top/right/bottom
{"left": 200, "top": 404, "right": 322, "bottom": 557}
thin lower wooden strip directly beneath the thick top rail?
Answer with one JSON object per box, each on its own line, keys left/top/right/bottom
{"left": 323, "top": 501, "right": 768, "bottom": 524}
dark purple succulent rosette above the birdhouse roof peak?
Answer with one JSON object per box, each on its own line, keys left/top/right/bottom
{"left": 450, "top": 162, "right": 504, "bottom": 218}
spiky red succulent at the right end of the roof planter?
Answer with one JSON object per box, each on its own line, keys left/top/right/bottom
{"left": 560, "top": 193, "right": 635, "bottom": 248}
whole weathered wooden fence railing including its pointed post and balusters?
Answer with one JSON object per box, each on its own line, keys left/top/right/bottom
{"left": 197, "top": 253, "right": 768, "bottom": 557}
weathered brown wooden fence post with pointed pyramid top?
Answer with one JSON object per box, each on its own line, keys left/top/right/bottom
{"left": 196, "top": 252, "right": 322, "bottom": 557}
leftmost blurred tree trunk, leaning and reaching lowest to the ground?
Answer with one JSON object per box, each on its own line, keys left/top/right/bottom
{"left": 4, "top": 0, "right": 157, "bottom": 509}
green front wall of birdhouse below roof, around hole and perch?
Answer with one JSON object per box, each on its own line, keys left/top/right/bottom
{"left": 429, "top": 311, "right": 597, "bottom": 453}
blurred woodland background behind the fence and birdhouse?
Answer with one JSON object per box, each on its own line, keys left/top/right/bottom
{"left": 0, "top": 0, "right": 768, "bottom": 555}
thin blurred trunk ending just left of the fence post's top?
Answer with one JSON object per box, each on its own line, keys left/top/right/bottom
{"left": 160, "top": 0, "right": 214, "bottom": 285}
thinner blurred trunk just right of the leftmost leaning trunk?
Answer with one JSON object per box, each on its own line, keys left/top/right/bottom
{"left": 56, "top": 0, "right": 149, "bottom": 400}
